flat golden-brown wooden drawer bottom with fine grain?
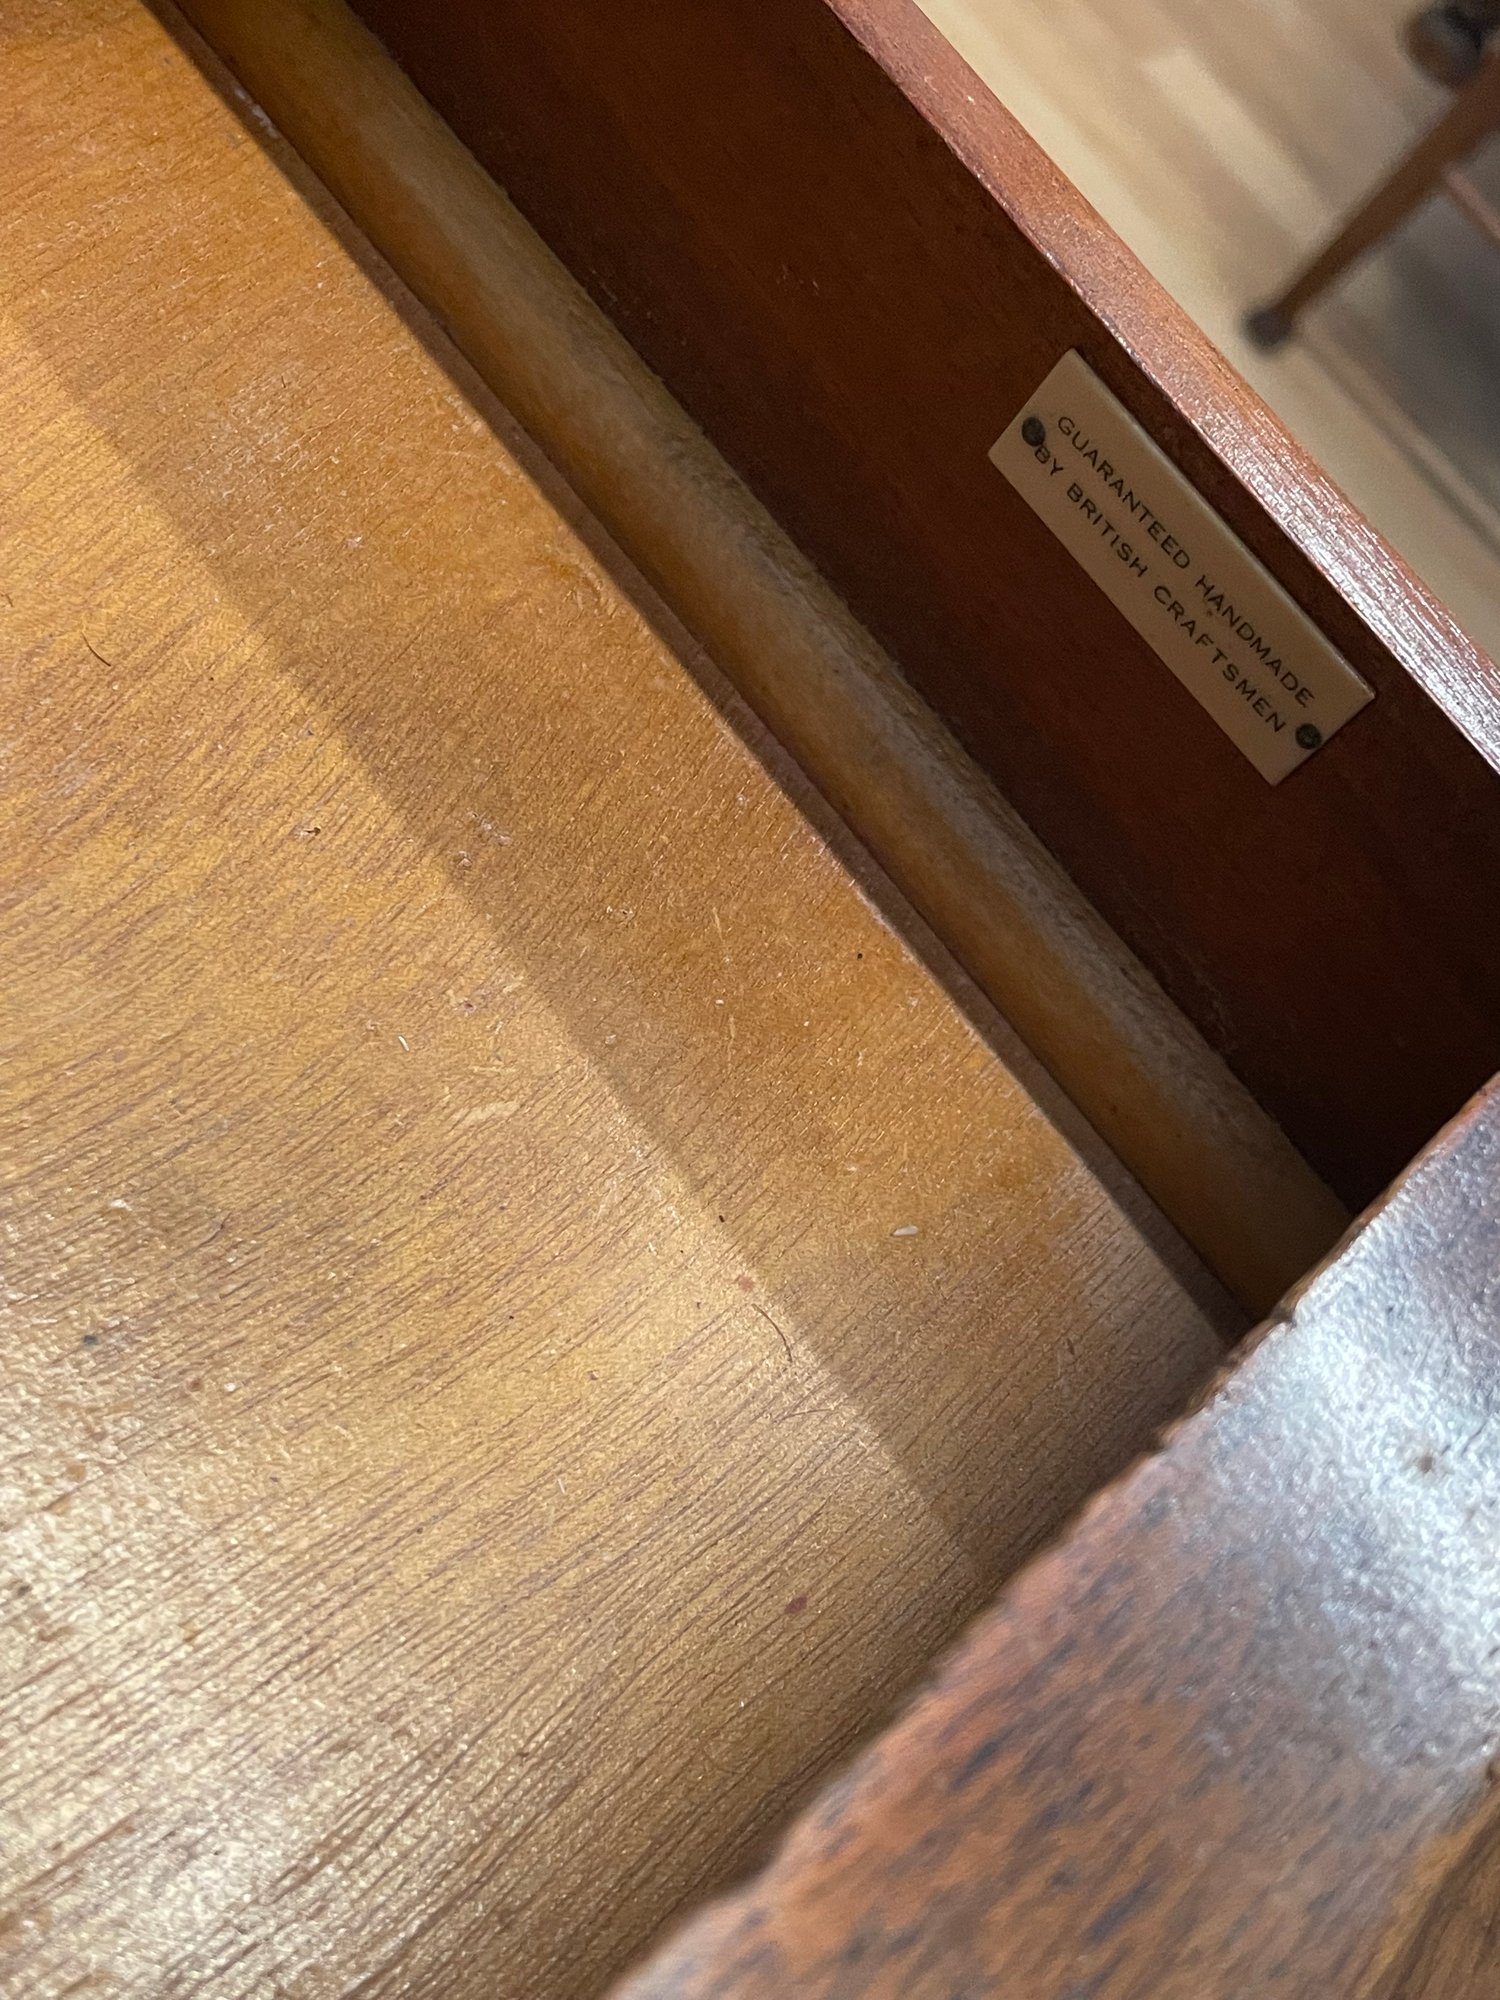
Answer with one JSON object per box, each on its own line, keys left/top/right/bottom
{"left": 0, "top": 0, "right": 1236, "bottom": 2000}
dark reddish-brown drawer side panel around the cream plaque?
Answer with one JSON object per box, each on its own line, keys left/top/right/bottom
{"left": 346, "top": 0, "right": 1500, "bottom": 1202}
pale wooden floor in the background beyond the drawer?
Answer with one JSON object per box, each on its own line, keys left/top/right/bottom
{"left": 924, "top": 0, "right": 1500, "bottom": 652}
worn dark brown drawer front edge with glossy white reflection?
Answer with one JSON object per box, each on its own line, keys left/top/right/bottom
{"left": 620, "top": 1088, "right": 1500, "bottom": 2000}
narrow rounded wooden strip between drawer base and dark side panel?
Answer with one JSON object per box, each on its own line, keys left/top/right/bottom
{"left": 170, "top": 0, "right": 1348, "bottom": 1318}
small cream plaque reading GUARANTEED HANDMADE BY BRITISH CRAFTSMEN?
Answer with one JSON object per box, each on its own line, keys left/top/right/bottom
{"left": 990, "top": 352, "right": 1374, "bottom": 784}
